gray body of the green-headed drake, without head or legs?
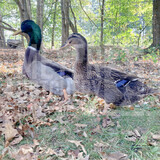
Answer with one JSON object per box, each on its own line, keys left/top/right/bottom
{"left": 23, "top": 47, "right": 75, "bottom": 96}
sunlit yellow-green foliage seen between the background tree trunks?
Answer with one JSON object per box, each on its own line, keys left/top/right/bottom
{"left": 0, "top": 0, "right": 153, "bottom": 47}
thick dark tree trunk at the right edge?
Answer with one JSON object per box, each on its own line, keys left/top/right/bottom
{"left": 152, "top": 0, "right": 160, "bottom": 46}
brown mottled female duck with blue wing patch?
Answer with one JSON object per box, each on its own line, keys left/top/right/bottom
{"left": 61, "top": 33, "right": 155, "bottom": 106}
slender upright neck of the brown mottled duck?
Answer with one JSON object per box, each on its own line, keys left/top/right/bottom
{"left": 76, "top": 44, "right": 88, "bottom": 65}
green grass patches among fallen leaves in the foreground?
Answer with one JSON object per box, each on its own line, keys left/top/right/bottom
{"left": 0, "top": 100, "right": 160, "bottom": 160}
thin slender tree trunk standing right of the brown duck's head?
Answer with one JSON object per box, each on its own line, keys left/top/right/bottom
{"left": 100, "top": 0, "right": 105, "bottom": 55}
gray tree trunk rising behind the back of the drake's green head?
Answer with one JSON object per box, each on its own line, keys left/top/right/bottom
{"left": 37, "top": 0, "right": 44, "bottom": 32}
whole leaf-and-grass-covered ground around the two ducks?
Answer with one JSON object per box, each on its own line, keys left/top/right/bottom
{"left": 0, "top": 46, "right": 160, "bottom": 160}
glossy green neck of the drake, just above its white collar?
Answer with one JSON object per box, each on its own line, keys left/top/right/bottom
{"left": 28, "top": 31, "right": 42, "bottom": 50}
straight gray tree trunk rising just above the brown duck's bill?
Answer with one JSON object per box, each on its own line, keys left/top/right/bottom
{"left": 61, "top": 0, "right": 70, "bottom": 44}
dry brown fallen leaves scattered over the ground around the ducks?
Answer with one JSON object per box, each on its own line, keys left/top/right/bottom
{"left": 0, "top": 50, "right": 160, "bottom": 160}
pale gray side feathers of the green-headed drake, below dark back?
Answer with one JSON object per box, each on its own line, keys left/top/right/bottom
{"left": 25, "top": 61, "right": 67, "bottom": 96}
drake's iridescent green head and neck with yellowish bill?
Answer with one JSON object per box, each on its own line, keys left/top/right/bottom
{"left": 14, "top": 20, "right": 42, "bottom": 50}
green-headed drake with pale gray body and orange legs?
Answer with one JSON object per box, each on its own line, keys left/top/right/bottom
{"left": 14, "top": 20, "right": 75, "bottom": 101}
